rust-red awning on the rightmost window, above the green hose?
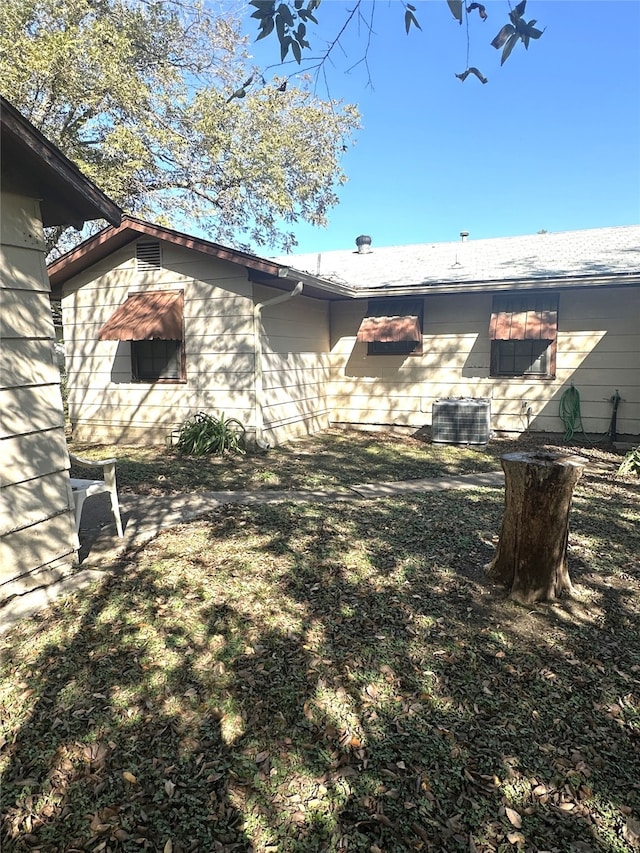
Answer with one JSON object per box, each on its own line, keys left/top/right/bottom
{"left": 489, "top": 294, "right": 558, "bottom": 341}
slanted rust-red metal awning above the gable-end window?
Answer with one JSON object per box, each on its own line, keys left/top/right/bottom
{"left": 98, "top": 290, "right": 184, "bottom": 341}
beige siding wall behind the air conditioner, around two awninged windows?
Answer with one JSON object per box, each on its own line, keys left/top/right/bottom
{"left": 330, "top": 287, "right": 640, "bottom": 435}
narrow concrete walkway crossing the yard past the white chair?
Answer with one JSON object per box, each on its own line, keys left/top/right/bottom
{"left": 0, "top": 471, "right": 504, "bottom": 633}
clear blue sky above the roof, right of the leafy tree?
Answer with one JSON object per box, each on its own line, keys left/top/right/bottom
{"left": 242, "top": 0, "right": 640, "bottom": 255}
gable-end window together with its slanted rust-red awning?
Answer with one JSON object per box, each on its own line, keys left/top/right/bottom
{"left": 98, "top": 290, "right": 186, "bottom": 382}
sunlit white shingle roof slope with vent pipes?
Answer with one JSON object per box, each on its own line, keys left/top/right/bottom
{"left": 274, "top": 225, "right": 640, "bottom": 291}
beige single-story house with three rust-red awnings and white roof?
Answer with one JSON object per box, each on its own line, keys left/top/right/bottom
{"left": 49, "top": 217, "right": 640, "bottom": 445}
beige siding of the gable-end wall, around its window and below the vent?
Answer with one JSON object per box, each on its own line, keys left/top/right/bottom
{"left": 62, "top": 241, "right": 254, "bottom": 444}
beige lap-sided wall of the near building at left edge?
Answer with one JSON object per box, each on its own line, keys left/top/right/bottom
{"left": 0, "top": 193, "right": 77, "bottom": 598}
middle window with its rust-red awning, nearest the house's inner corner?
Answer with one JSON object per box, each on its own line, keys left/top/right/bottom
{"left": 357, "top": 297, "right": 424, "bottom": 355}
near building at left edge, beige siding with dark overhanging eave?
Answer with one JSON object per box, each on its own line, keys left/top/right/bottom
{"left": 0, "top": 98, "right": 121, "bottom": 600}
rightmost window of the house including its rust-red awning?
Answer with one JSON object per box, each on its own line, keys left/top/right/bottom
{"left": 490, "top": 293, "right": 558, "bottom": 379}
